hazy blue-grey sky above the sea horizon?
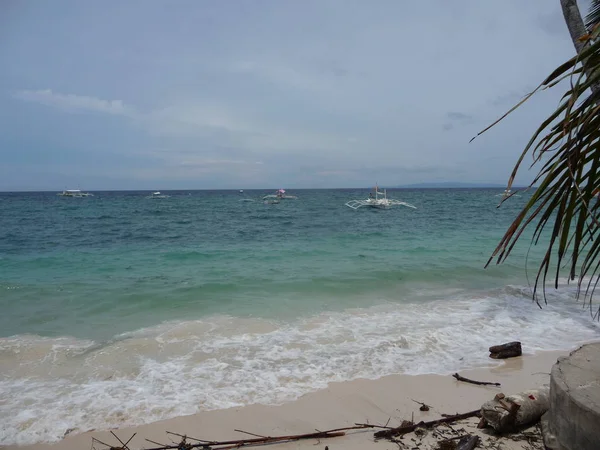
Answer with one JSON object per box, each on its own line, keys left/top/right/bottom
{"left": 0, "top": 0, "right": 586, "bottom": 191}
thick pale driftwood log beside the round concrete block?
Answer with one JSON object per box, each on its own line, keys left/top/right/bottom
{"left": 481, "top": 386, "right": 550, "bottom": 433}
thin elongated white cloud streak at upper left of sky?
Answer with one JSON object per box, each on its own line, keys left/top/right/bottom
{"left": 14, "top": 89, "right": 135, "bottom": 116}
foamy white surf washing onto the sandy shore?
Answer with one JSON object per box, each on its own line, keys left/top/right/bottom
{"left": 0, "top": 286, "right": 600, "bottom": 445}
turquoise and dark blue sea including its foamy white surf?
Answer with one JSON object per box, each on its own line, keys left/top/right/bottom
{"left": 0, "top": 189, "right": 600, "bottom": 445}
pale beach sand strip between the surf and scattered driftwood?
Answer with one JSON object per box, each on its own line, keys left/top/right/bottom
{"left": 8, "top": 352, "right": 569, "bottom": 450}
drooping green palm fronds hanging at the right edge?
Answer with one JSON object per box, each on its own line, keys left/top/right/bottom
{"left": 477, "top": 26, "right": 600, "bottom": 319}
